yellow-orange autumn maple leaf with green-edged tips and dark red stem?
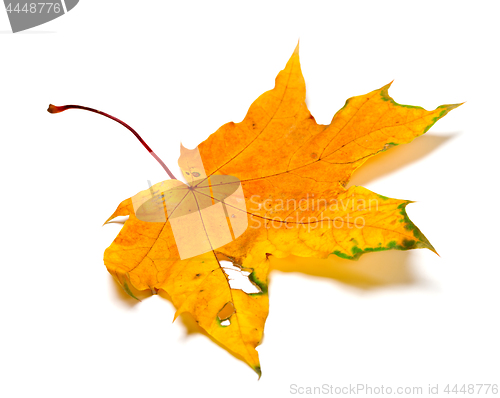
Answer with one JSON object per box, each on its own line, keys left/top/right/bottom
{"left": 49, "top": 42, "right": 460, "bottom": 375}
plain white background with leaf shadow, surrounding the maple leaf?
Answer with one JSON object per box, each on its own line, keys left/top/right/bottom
{"left": 0, "top": 0, "right": 500, "bottom": 397}
